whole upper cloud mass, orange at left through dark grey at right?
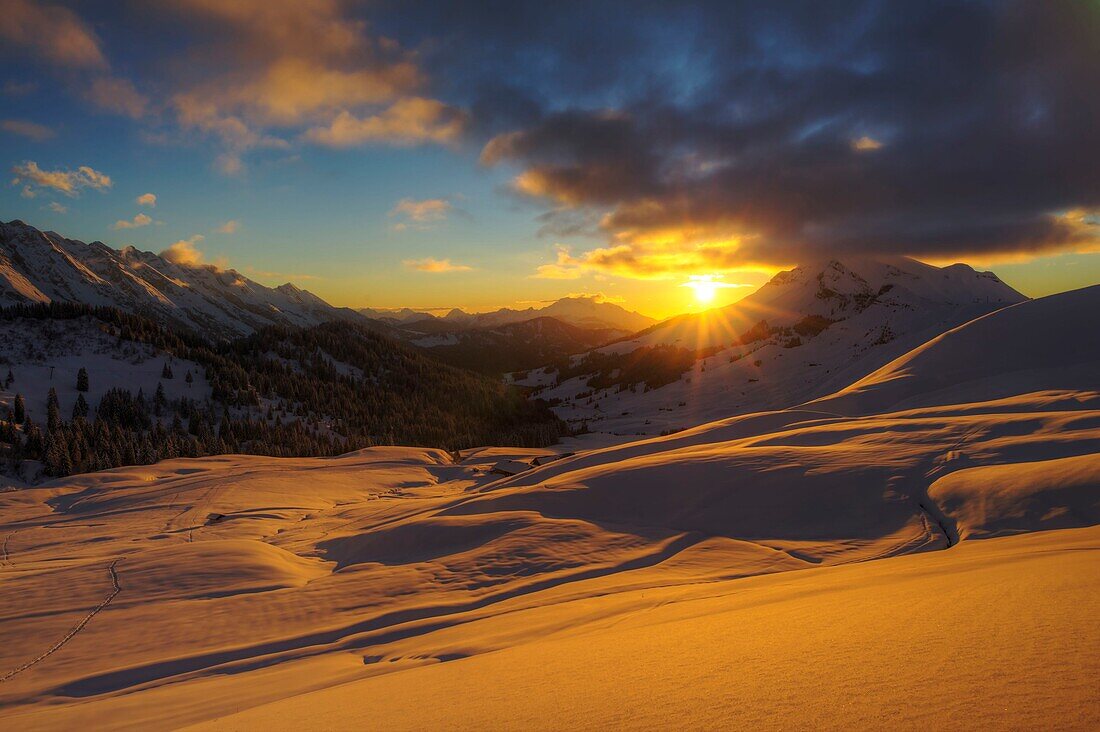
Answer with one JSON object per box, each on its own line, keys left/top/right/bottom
{"left": 8, "top": 0, "right": 1100, "bottom": 270}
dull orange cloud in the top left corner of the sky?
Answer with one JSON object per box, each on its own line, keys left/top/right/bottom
{"left": 0, "top": 0, "right": 107, "bottom": 68}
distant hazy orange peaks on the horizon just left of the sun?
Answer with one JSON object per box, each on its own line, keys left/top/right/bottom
{"left": 360, "top": 295, "right": 657, "bottom": 334}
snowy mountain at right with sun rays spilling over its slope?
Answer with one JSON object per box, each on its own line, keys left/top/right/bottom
{"left": 520, "top": 258, "right": 1026, "bottom": 434}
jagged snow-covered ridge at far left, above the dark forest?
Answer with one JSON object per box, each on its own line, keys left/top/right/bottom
{"left": 0, "top": 220, "right": 361, "bottom": 339}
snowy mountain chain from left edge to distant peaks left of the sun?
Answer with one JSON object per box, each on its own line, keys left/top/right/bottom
{"left": 0, "top": 220, "right": 656, "bottom": 353}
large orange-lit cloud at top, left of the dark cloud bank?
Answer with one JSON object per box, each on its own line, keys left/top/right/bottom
{"left": 144, "top": 0, "right": 464, "bottom": 169}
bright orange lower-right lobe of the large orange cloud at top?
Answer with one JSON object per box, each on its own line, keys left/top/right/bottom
{"left": 306, "top": 97, "right": 466, "bottom": 148}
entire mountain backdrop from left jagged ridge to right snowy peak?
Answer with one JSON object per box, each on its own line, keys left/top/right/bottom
{"left": 0, "top": 221, "right": 1026, "bottom": 434}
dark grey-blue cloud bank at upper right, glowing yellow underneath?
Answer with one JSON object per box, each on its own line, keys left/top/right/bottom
{"left": 426, "top": 0, "right": 1100, "bottom": 274}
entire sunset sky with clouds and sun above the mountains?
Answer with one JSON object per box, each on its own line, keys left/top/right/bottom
{"left": 0, "top": 0, "right": 1100, "bottom": 317}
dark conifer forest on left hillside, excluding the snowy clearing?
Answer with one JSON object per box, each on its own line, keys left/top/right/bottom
{"left": 0, "top": 303, "right": 567, "bottom": 476}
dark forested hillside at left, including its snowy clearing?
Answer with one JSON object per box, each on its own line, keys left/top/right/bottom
{"left": 0, "top": 303, "right": 563, "bottom": 483}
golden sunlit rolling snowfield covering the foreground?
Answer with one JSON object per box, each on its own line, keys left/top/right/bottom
{"left": 0, "top": 288, "right": 1100, "bottom": 730}
